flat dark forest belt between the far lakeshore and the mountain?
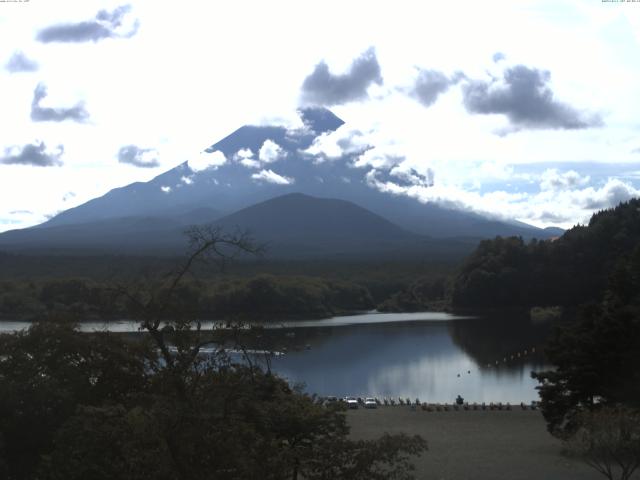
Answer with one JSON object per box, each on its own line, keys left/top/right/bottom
{"left": 0, "top": 253, "right": 456, "bottom": 321}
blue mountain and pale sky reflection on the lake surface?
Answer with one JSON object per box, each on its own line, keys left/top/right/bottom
{"left": 267, "top": 319, "right": 542, "bottom": 403}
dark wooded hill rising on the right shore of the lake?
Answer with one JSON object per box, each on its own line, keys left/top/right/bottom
{"left": 451, "top": 199, "right": 640, "bottom": 308}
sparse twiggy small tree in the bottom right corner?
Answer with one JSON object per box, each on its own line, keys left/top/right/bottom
{"left": 566, "top": 407, "right": 640, "bottom": 480}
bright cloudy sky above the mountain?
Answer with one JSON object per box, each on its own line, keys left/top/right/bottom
{"left": 0, "top": 0, "right": 640, "bottom": 231}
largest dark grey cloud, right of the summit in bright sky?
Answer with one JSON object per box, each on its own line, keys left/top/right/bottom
{"left": 463, "top": 65, "right": 603, "bottom": 129}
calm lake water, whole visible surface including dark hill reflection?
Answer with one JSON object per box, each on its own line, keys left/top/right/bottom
{"left": 0, "top": 312, "right": 549, "bottom": 403}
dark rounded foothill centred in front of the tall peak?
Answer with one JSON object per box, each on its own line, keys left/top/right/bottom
{"left": 210, "top": 193, "right": 475, "bottom": 258}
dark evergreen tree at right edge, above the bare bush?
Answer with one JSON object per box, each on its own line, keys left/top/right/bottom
{"left": 533, "top": 247, "right": 640, "bottom": 438}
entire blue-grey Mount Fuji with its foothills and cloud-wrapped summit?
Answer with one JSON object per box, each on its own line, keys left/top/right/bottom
{"left": 0, "top": 108, "right": 558, "bottom": 257}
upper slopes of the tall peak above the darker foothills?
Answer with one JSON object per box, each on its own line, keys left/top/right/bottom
{"left": 31, "top": 108, "right": 553, "bottom": 238}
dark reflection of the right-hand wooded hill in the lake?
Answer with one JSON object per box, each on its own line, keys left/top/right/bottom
{"left": 448, "top": 314, "right": 552, "bottom": 368}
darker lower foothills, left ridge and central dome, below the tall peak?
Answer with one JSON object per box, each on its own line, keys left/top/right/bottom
{"left": 0, "top": 193, "right": 474, "bottom": 259}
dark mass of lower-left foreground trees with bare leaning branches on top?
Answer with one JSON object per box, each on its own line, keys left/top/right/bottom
{"left": 0, "top": 226, "right": 426, "bottom": 480}
